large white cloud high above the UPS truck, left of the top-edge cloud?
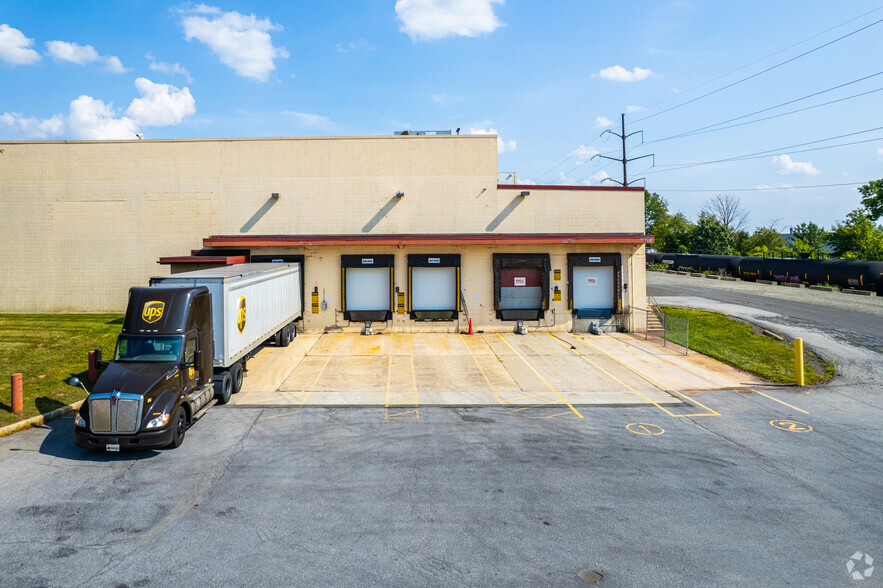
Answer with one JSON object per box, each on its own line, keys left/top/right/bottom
{"left": 181, "top": 4, "right": 288, "bottom": 82}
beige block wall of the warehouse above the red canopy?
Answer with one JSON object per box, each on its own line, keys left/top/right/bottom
{"left": 0, "top": 136, "right": 643, "bottom": 312}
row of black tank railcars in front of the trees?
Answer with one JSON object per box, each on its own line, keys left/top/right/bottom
{"left": 647, "top": 253, "right": 883, "bottom": 295}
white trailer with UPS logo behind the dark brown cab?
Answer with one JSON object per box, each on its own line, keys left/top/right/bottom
{"left": 150, "top": 263, "right": 303, "bottom": 371}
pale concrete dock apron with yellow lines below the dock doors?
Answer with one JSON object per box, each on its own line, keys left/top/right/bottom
{"left": 231, "top": 332, "right": 762, "bottom": 418}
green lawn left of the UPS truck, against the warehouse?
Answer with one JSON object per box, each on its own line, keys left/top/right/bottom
{"left": 0, "top": 314, "right": 123, "bottom": 427}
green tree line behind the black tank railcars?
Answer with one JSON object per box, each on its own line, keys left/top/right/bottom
{"left": 644, "top": 179, "right": 883, "bottom": 260}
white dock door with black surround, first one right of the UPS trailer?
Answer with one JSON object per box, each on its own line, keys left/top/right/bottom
{"left": 341, "top": 255, "right": 393, "bottom": 321}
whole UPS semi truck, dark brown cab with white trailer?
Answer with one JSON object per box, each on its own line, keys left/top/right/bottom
{"left": 74, "top": 263, "right": 303, "bottom": 451}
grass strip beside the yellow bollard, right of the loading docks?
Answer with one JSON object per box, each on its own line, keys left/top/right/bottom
{"left": 660, "top": 307, "right": 836, "bottom": 384}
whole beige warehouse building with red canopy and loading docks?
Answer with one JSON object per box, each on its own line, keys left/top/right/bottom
{"left": 0, "top": 134, "right": 652, "bottom": 332}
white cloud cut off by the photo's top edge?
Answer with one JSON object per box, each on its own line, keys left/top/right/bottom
{"left": 395, "top": 0, "right": 504, "bottom": 41}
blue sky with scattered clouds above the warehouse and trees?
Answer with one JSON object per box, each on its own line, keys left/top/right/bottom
{"left": 0, "top": 0, "right": 883, "bottom": 230}
